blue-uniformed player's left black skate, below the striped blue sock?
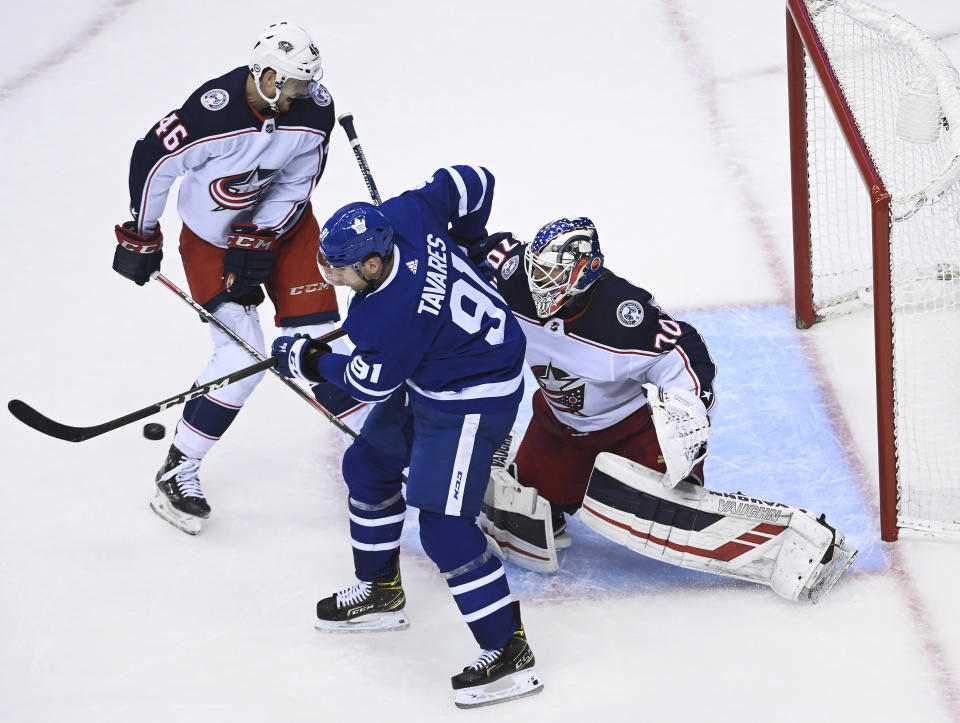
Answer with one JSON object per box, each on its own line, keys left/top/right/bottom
{"left": 314, "top": 563, "right": 410, "bottom": 633}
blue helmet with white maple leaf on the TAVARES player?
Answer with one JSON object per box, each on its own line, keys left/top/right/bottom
{"left": 317, "top": 201, "right": 393, "bottom": 276}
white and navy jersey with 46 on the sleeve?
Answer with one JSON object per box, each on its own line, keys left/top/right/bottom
{"left": 130, "top": 66, "right": 335, "bottom": 240}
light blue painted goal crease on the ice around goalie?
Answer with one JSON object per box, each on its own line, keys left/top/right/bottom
{"left": 405, "top": 306, "right": 885, "bottom": 600}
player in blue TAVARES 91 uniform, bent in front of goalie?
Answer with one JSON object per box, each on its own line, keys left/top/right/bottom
{"left": 273, "top": 166, "right": 542, "bottom": 707}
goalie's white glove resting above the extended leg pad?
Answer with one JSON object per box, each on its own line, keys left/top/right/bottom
{"left": 643, "top": 384, "right": 710, "bottom": 487}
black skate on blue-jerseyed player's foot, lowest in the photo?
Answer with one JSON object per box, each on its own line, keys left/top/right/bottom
{"left": 450, "top": 602, "right": 543, "bottom": 708}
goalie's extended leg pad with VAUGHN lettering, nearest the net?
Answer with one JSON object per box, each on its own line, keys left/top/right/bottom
{"left": 581, "top": 453, "right": 856, "bottom": 602}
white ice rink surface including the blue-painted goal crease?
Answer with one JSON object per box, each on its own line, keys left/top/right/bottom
{"left": 0, "top": 0, "right": 960, "bottom": 723}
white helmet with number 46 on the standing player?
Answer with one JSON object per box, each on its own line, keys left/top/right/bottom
{"left": 249, "top": 21, "right": 323, "bottom": 110}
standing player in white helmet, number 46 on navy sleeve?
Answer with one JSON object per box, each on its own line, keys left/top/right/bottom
{"left": 113, "top": 22, "right": 358, "bottom": 534}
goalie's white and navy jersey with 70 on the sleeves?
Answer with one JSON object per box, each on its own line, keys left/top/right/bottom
{"left": 487, "top": 238, "right": 717, "bottom": 432}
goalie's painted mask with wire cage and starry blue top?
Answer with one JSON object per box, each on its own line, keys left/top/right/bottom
{"left": 523, "top": 216, "right": 603, "bottom": 319}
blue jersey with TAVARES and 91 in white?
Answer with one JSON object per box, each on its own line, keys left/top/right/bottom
{"left": 319, "top": 166, "right": 524, "bottom": 414}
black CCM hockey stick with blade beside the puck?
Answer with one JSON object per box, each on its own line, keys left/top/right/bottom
{"left": 7, "top": 329, "right": 346, "bottom": 442}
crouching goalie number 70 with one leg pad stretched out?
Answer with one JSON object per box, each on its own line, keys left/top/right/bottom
{"left": 475, "top": 217, "right": 856, "bottom": 601}
